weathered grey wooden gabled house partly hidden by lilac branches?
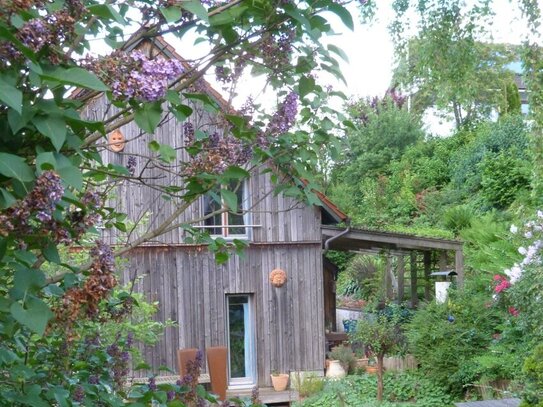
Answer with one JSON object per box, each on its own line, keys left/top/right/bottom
{"left": 85, "top": 38, "right": 345, "bottom": 388}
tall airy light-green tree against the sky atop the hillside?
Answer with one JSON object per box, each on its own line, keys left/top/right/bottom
{"left": 391, "top": 0, "right": 519, "bottom": 128}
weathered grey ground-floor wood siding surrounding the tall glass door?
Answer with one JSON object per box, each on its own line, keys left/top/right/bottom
{"left": 123, "top": 244, "right": 324, "bottom": 386}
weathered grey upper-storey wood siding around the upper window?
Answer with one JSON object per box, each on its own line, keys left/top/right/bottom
{"left": 85, "top": 97, "right": 321, "bottom": 244}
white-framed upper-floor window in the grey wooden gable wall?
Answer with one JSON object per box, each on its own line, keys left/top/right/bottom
{"left": 204, "top": 182, "right": 248, "bottom": 239}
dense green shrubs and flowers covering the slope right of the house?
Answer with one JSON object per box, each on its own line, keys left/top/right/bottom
{"left": 328, "top": 79, "right": 543, "bottom": 405}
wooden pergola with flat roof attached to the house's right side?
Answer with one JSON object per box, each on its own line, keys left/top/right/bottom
{"left": 322, "top": 225, "right": 464, "bottom": 308}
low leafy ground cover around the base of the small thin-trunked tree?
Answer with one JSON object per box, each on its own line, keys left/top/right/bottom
{"left": 299, "top": 372, "right": 452, "bottom": 407}
